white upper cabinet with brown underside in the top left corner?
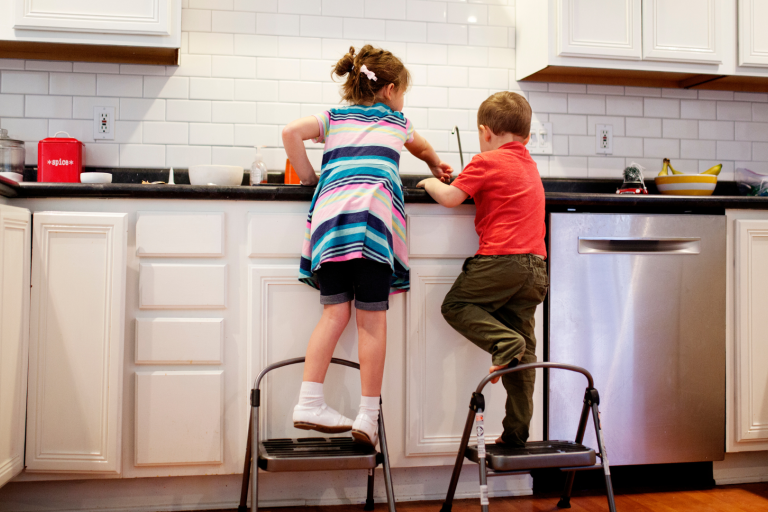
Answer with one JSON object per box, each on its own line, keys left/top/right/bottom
{"left": 0, "top": 0, "right": 182, "bottom": 64}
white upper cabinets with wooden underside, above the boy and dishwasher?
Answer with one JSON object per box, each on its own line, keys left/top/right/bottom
{"left": 515, "top": 0, "right": 768, "bottom": 92}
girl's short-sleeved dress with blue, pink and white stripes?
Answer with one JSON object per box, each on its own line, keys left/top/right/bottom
{"left": 299, "top": 103, "right": 413, "bottom": 293}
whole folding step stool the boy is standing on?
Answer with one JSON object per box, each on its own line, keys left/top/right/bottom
{"left": 440, "top": 363, "right": 616, "bottom": 512}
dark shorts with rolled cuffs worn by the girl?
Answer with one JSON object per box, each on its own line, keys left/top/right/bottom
{"left": 317, "top": 258, "right": 392, "bottom": 311}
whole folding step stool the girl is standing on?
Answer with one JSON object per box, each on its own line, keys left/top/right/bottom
{"left": 237, "top": 357, "right": 395, "bottom": 512}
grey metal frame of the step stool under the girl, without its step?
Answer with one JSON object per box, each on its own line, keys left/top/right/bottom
{"left": 237, "top": 357, "right": 395, "bottom": 512}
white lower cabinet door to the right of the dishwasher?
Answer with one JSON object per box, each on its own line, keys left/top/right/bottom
{"left": 726, "top": 210, "right": 768, "bottom": 452}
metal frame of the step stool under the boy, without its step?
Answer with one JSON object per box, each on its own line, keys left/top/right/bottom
{"left": 440, "top": 362, "right": 616, "bottom": 512}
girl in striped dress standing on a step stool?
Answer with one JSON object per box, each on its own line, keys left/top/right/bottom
{"left": 283, "top": 45, "right": 453, "bottom": 446}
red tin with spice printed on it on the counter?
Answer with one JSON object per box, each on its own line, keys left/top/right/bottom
{"left": 37, "top": 132, "right": 85, "bottom": 183}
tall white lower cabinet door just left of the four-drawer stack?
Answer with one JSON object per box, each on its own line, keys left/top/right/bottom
{"left": 26, "top": 212, "right": 127, "bottom": 473}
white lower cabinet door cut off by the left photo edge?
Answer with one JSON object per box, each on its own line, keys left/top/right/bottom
{"left": 0, "top": 205, "right": 32, "bottom": 487}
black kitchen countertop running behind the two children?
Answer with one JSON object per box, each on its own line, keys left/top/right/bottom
{"left": 6, "top": 169, "right": 768, "bottom": 214}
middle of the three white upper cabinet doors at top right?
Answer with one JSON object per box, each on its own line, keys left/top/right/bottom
{"left": 643, "top": 0, "right": 733, "bottom": 64}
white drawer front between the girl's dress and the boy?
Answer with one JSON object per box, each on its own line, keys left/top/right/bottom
{"left": 407, "top": 215, "right": 479, "bottom": 258}
